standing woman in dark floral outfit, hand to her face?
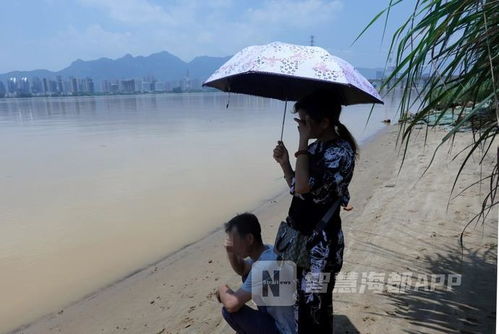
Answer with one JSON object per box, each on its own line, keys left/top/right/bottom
{"left": 273, "top": 92, "right": 358, "bottom": 333}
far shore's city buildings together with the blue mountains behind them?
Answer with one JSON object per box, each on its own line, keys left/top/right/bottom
{"left": 0, "top": 48, "right": 390, "bottom": 98}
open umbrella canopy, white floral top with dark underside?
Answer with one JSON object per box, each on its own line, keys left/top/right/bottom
{"left": 203, "top": 42, "right": 383, "bottom": 105}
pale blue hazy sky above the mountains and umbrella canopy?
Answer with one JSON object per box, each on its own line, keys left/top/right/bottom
{"left": 0, "top": 0, "right": 414, "bottom": 73}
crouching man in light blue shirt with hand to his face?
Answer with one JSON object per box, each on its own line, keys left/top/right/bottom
{"left": 217, "top": 213, "right": 296, "bottom": 334}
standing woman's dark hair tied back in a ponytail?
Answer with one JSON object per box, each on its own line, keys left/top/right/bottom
{"left": 293, "top": 90, "right": 359, "bottom": 156}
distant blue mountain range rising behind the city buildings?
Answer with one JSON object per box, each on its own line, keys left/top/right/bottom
{"left": 0, "top": 51, "right": 383, "bottom": 82}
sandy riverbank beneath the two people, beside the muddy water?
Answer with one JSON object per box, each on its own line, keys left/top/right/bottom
{"left": 9, "top": 126, "right": 497, "bottom": 334}
